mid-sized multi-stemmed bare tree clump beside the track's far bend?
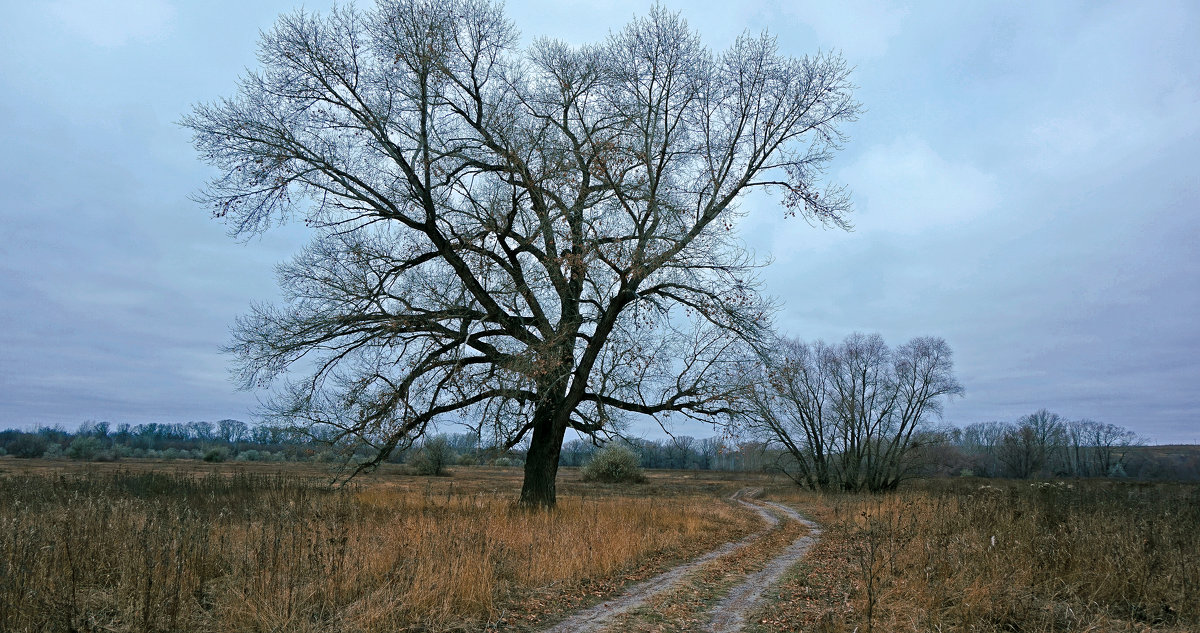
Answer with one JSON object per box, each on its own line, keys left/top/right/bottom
{"left": 744, "top": 333, "right": 962, "bottom": 490}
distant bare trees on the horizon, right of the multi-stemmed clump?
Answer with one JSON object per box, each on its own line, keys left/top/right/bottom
{"left": 955, "top": 409, "right": 1140, "bottom": 477}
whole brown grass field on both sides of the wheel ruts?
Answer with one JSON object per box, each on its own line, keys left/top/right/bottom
{"left": 0, "top": 458, "right": 1200, "bottom": 633}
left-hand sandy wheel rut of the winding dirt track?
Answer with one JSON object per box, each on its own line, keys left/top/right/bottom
{"left": 545, "top": 488, "right": 777, "bottom": 633}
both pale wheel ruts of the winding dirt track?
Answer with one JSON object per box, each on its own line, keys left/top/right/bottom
{"left": 546, "top": 488, "right": 821, "bottom": 633}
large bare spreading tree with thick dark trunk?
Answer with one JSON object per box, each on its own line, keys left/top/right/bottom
{"left": 182, "top": 0, "right": 859, "bottom": 506}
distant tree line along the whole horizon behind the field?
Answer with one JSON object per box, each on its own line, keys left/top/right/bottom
{"left": 0, "top": 409, "right": 1200, "bottom": 481}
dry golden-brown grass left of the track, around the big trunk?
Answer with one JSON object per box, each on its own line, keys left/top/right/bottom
{"left": 0, "top": 460, "right": 757, "bottom": 631}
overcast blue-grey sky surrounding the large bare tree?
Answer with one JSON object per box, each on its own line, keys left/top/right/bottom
{"left": 0, "top": 0, "right": 1200, "bottom": 442}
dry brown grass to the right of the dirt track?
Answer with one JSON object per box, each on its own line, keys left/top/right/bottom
{"left": 760, "top": 481, "right": 1200, "bottom": 632}
